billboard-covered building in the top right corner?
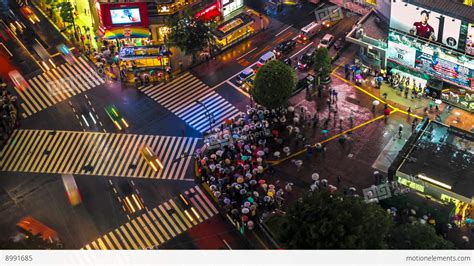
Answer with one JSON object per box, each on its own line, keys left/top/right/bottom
{"left": 346, "top": 0, "right": 474, "bottom": 112}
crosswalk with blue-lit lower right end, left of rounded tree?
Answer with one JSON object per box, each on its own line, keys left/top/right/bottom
{"left": 138, "top": 72, "right": 239, "bottom": 132}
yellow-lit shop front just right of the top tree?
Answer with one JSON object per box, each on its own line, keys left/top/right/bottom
{"left": 212, "top": 13, "right": 254, "bottom": 50}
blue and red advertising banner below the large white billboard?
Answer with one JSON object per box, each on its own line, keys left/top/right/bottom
{"left": 415, "top": 51, "right": 474, "bottom": 88}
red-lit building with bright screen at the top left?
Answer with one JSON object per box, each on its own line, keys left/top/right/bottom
{"left": 90, "top": 0, "right": 243, "bottom": 44}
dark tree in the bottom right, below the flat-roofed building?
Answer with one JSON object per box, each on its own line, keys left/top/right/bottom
{"left": 387, "top": 223, "right": 454, "bottom": 249}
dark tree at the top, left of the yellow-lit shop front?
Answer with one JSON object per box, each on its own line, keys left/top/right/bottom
{"left": 168, "top": 15, "right": 211, "bottom": 62}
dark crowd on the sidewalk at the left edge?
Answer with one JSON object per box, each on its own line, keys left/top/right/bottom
{"left": 0, "top": 80, "right": 19, "bottom": 146}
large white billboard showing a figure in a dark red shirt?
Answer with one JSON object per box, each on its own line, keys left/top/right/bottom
{"left": 390, "top": 1, "right": 467, "bottom": 51}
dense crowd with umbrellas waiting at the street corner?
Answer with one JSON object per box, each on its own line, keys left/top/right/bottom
{"left": 197, "top": 107, "right": 306, "bottom": 229}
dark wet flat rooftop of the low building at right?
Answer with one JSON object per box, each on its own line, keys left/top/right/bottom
{"left": 399, "top": 121, "right": 474, "bottom": 198}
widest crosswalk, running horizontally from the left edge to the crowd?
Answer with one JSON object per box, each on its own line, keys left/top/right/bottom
{"left": 0, "top": 130, "right": 199, "bottom": 180}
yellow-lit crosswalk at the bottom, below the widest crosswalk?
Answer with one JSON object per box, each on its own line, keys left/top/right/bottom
{"left": 82, "top": 186, "right": 218, "bottom": 250}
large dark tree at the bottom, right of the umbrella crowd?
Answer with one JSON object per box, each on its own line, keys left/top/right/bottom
{"left": 277, "top": 191, "right": 393, "bottom": 249}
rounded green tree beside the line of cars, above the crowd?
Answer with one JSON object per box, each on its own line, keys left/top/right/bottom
{"left": 251, "top": 60, "right": 297, "bottom": 109}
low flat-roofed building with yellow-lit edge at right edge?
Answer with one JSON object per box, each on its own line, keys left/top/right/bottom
{"left": 388, "top": 119, "right": 474, "bottom": 228}
